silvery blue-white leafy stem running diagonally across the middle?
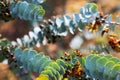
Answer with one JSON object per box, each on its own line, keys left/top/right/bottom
{"left": 10, "top": 3, "right": 119, "bottom": 47}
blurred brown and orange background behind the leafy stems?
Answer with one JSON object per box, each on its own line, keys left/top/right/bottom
{"left": 0, "top": 0, "right": 120, "bottom": 80}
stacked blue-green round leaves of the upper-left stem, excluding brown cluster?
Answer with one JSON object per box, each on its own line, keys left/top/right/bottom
{"left": 10, "top": 1, "right": 45, "bottom": 21}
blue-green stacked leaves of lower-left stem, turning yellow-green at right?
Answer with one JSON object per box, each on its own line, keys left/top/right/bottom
{"left": 14, "top": 48, "right": 66, "bottom": 80}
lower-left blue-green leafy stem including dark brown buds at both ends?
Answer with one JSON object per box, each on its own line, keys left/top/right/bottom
{"left": 0, "top": 39, "right": 84, "bottom": 80}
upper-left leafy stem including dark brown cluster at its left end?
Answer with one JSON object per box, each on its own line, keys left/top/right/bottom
{"left": 0, "top": 0, "right": 45, "bottom": 21}
